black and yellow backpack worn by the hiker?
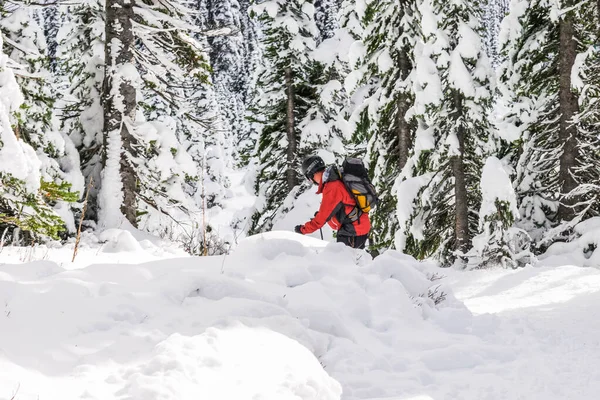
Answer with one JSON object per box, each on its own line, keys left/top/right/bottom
{"left": 340, "top": 157, "right": 379, "bottom": 222}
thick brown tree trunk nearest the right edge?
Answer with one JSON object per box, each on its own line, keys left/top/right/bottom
{"left": 558, "top": 12, "right": 579, "bottom": 221}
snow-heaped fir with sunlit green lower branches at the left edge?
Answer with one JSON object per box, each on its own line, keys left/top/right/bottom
{"left": 0, "top": 33, "right": 74, "bottom": 244}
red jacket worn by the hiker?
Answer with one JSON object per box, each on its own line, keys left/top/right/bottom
{"left": 300, "top": 172, "right": 371, "bottom": 236}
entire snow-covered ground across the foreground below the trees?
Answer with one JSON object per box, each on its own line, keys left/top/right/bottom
{"left": 0, "top": 231, "right": 600, "bottom": 400}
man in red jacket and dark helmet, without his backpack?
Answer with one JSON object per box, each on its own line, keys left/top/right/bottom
{"left": 294, "top": 156, "right": 371, "bottom": 249}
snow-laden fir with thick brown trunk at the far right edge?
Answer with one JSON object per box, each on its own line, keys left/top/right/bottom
{"left": 500, "top": 0, "right": 598, "bottom": 251}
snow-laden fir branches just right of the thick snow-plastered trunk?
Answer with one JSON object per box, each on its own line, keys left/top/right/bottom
{"left": 129, "top": 2, "right": 231, "bottom": 240}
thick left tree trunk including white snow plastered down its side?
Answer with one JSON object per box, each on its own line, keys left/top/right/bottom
{"left": 102, "top": 0, "right": 137, "bottom": 226}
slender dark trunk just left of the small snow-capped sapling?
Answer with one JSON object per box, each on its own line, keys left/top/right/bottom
{"left": 450, "top": 91, "right": 469, "bottom": 252}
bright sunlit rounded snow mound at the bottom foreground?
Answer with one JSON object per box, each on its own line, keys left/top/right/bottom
{"left": 107, "top": 325, "right": 342, "bottom": 400}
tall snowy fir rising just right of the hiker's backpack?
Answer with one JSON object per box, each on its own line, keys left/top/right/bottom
{"left": 346, "top": 0, "right": 419, "bottom": 248}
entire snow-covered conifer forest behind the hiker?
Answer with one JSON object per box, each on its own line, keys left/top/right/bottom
{"left": 0, "top": 0, "right": 600, "bottom": 268}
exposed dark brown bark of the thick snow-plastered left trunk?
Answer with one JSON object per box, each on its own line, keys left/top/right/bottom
{"left": 103, "top": 0, "right": 137, "bottom": 226}
